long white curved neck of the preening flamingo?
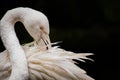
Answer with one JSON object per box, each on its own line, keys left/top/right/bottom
{"left": 0, "top": 10, "right": 28, "bottom": 80}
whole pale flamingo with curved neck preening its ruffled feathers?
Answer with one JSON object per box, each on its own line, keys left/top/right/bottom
{"left": 0, "top": 7, "right": 94, "bottom": 80}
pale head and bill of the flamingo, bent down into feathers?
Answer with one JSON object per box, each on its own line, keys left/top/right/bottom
{"left": 21, "top": 8, "right": 51, "bottom": 47}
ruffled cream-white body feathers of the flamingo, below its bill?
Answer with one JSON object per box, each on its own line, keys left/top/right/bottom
{"left": 0, "top": 42, "right": 94, "bottom": 80}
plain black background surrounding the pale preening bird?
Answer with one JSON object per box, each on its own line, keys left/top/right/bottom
{"left": 0, "top": 0, "right": 120, "bottom": 80}
